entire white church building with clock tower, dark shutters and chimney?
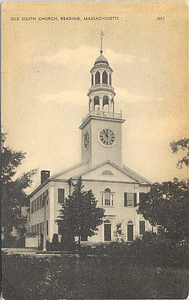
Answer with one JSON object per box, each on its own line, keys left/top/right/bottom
{"left": 28, "top": 46, "right": 152, "bottom": 243}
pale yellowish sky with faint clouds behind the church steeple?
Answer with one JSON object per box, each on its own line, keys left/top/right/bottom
{"left": 2, "top": 1, "right": 188, "bottom": 192}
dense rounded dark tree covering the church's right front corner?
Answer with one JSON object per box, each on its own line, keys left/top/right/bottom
{"left": 138, "top": 178, "right": 189, "bottom": 242}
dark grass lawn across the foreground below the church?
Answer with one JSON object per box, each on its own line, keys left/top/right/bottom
{"left": 3, "top": 255, "right": 188, "bottom": 300}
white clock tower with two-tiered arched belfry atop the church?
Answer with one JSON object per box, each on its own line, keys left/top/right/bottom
{"left": 79, "top": 48, "right": 125, "bottom": 167}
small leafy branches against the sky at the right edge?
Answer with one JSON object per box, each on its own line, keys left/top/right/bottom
{"left": 170, "top": 138, "right": 189, "bottom": 169}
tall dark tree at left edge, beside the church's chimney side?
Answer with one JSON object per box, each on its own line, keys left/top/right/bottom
{"left": 1, "top": 133, "right": 36, "bottom": 245}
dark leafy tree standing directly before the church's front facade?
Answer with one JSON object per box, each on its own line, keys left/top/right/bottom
{"left": 56, "top": 177, "right": 104, "bottom": 245}
